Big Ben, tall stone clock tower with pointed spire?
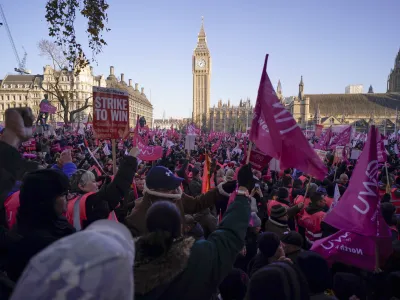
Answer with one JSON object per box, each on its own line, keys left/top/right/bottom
{"left": 192, "top": 17, "right": 211, "bottom": 128}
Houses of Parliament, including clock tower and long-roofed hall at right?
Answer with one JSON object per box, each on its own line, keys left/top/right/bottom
{"left": 192, "top": 17, "right": 400, "bottom": 132}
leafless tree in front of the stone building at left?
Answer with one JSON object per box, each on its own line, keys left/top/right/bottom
{"left": 38, "top": 40, "right": 91, "bottom": 123}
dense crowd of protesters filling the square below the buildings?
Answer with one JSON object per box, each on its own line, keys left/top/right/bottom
{"left": 0, "top": 108, "right": 400, "bottom": 300}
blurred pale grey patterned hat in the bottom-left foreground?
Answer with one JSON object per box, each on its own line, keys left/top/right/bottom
{"left": 11, "top": 220, "right": 135, "bottom": 300}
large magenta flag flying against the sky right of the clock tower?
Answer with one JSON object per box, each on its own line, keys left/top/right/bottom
{"left": 250, "top": 54, "right": 327, "bottom": 179}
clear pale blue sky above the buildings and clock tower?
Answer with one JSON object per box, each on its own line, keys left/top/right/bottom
{"left": 0, "top": 0, "right": 400, "bottom": 118}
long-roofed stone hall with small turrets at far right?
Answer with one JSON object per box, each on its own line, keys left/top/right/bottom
{"left": 285, "top": 47, "right": 400, "bottom": 132}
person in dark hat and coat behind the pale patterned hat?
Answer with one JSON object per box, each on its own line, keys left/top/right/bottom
{"left": 6, "top": 169, "right": 75, "bottom": 281}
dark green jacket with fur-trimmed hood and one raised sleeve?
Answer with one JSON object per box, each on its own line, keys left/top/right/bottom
{"left": 134, "top": 191, "right": 250, "bottom": 300}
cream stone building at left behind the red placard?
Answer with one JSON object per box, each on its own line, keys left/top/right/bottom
{"left": 0, "top": 65, "right": 153, "bottom": 127}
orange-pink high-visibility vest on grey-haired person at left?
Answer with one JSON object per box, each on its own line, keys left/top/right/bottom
{"left": 66, "top": 192, "right": 118, "bottom": 231}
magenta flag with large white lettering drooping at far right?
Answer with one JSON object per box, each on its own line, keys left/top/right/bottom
{"left": 324, "top": 126, "right": 391, "bottom": 237}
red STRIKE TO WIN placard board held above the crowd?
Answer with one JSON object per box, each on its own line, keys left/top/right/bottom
{"left": 93, "top": 86, "right": 129, "bottom": 139}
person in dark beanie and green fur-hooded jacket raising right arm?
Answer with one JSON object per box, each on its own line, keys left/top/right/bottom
{"left": 134, "top": 170, "right": 251, "bottom": 299}
